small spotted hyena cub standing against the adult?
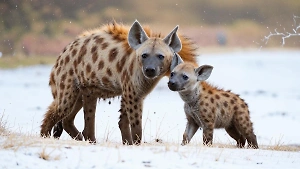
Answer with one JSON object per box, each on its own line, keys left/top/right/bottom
{"left": 168, "top": 54, "right": 258, "bottom": 148}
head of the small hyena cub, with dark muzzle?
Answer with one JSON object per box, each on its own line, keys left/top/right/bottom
{"left": 168, "top": 53, "right": 213, "bottom": 91}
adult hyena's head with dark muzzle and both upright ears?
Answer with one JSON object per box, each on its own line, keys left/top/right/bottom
{"left": 128, "top": 21, "right": 181, "bottom": 79}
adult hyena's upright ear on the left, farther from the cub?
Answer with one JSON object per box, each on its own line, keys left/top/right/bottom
{"left": 128, "top": 20, "right": 149, "bottom": 50}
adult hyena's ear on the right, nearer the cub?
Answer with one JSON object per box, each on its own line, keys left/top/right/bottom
{"left": 164, "top": 25, "right": 182, "bottom": 53}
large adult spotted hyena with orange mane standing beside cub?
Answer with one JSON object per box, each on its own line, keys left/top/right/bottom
{"left": 40, "top": 21, "right": 196, "bottom": 144}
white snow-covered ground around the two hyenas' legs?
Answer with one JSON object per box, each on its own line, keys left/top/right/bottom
{"left": 0, "top": 50, "right": 300, "bottom": 168}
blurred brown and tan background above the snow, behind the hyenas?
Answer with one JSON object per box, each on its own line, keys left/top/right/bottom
{"left": 0, "top": 0, "right": 300, "bottom": 58}
